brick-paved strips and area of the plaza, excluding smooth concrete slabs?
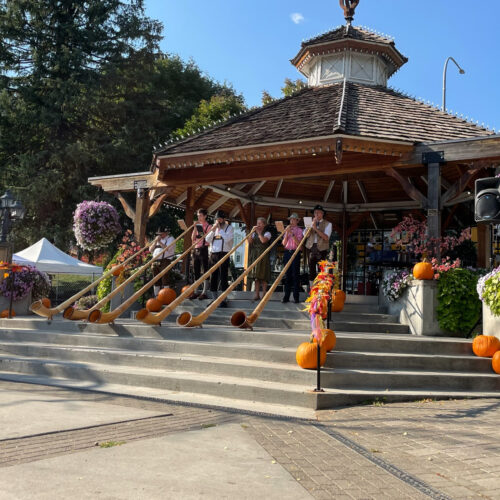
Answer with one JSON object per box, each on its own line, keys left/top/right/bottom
{"left": 0, "top": 382, "right": 500, "bottom": 499}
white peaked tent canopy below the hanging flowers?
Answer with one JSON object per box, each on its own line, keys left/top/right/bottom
{"left": 12, "top": 238, "right": 102, "bottom": 274}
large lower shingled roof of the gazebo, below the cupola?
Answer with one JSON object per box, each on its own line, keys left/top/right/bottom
{"left": 155, "top": 82, "right": 493, "bottom": 157}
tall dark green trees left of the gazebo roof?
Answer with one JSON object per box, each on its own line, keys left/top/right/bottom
{"left": 0, "top": 0, "right": 242, "bottom": 249}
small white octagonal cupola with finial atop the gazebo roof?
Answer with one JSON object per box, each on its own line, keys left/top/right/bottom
{"left": 291, "top": 0, "right": 408, "bottom": 87}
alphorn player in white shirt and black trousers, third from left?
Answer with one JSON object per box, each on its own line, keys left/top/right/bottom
{"left": 205, "top": 210, "right": 234, "bottom": 307}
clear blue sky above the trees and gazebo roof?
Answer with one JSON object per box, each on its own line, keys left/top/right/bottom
{"left": 146, "top": 0, "right": 500, "bottom": 130}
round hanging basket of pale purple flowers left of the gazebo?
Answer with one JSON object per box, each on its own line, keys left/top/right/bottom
{"left": 73, "top": 201, "right": 121, "bottom": 250}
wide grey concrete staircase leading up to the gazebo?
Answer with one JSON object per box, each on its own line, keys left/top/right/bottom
{"left": 0, "top": 293, "right": 500, "bottom": 415}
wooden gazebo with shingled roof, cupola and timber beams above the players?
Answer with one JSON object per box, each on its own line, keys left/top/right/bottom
{"left": 89, "top": 2, "right": 500, "bottom": 290}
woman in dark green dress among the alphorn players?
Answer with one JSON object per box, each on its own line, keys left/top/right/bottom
{"left": 248, "top": 217, "right": 271, "bottom": 301}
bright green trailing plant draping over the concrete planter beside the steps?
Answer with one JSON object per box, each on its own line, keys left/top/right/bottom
{"left": 437, "top": 268, "right": 481, "bottom": 334}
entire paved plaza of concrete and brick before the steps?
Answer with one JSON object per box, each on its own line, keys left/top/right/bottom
{"left": 0, "top": 381, "right": 500, "bottom": 499}
